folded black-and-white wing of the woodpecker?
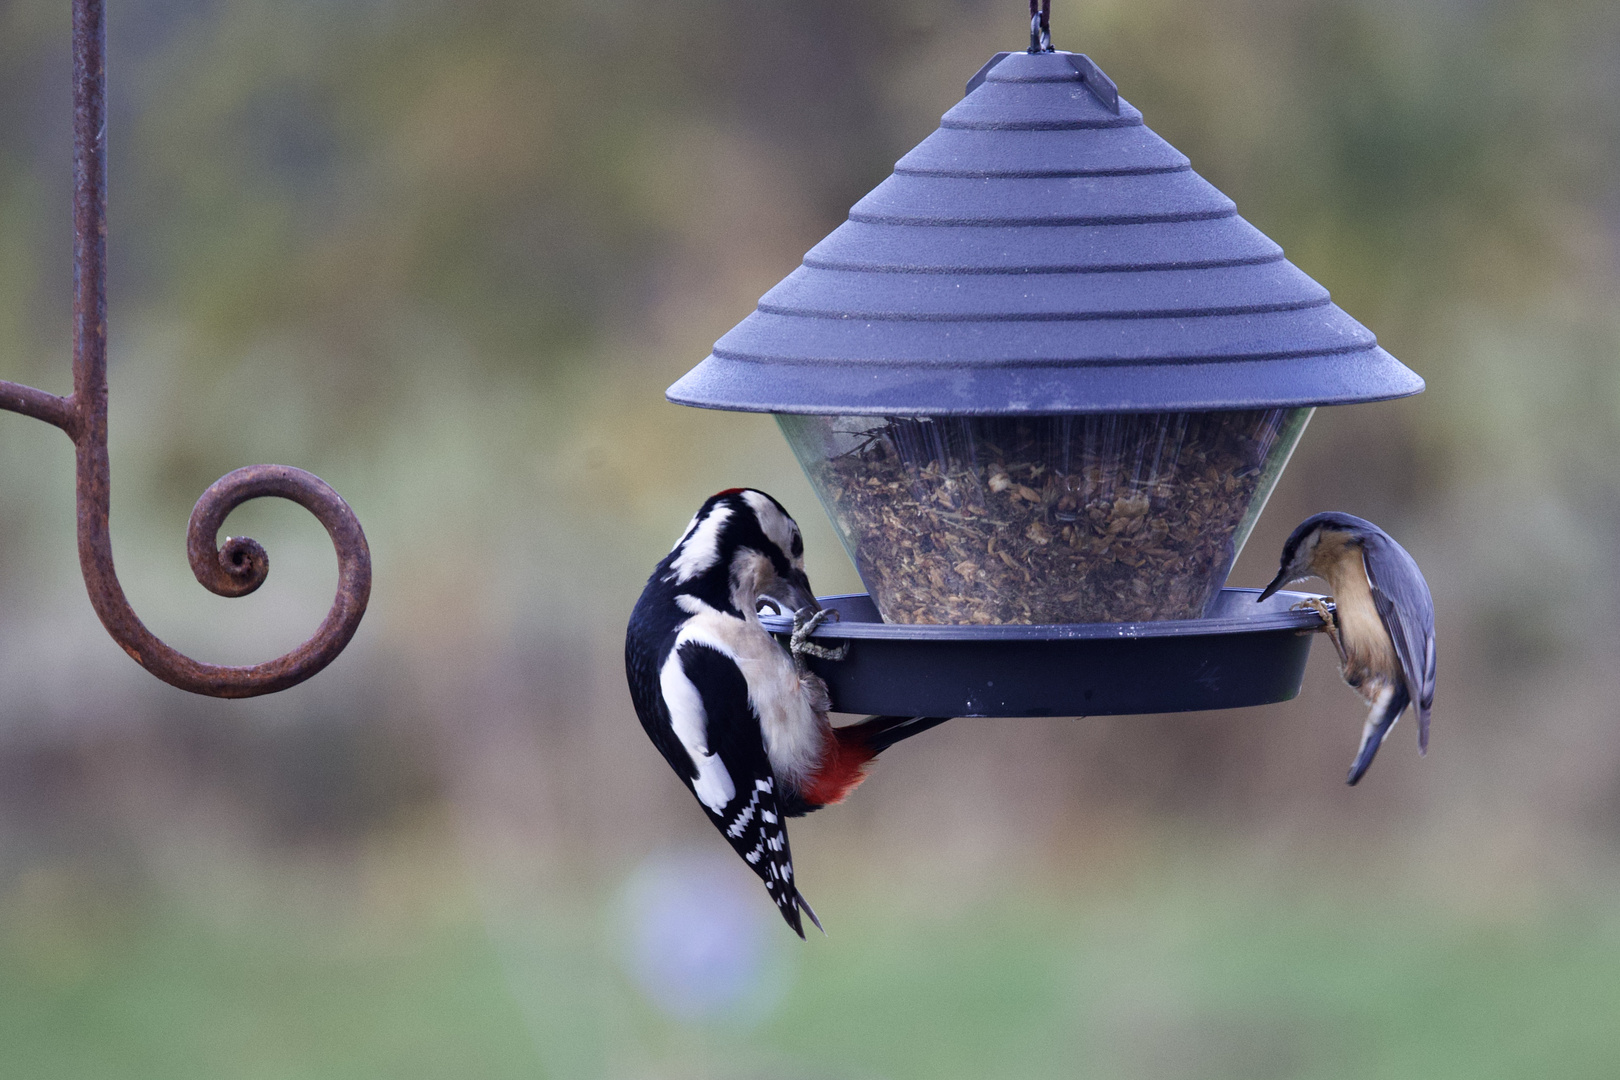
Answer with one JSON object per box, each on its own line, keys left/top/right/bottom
{"left": 661, "top": 641, "right": 821, "bottom": 938}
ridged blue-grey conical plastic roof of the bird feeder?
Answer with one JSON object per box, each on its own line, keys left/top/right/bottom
{"left": 667, "top": 52, "right": 1424, "bottom": 416}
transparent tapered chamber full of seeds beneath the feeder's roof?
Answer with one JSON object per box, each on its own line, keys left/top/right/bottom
{"left": 776, "top": 408, "right": 1314, "bottom": 625}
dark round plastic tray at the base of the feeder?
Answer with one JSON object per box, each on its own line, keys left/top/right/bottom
{"left": 761, "top": 589, "right": 1322, "bottom": 716}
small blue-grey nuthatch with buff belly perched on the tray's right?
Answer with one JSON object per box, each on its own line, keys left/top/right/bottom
{"left": 1260, "top": 513, "right": 1434, "bottom": 784}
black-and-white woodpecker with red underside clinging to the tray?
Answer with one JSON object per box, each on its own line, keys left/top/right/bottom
{"left": 624, "top": 487, "right": 949, "bottom": 938}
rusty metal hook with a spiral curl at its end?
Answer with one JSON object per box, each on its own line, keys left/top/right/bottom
{"left": 0, "top": 0, "right": 371, "bottom": 698}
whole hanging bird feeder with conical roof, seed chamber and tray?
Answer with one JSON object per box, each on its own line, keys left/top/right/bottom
{"left": 667, "top": 35, "right": 1424, "bottom": 716}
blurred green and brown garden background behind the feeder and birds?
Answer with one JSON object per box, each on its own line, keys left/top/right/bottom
{"left": 0, "top": 0, "right": 1620, "bottom": 1080}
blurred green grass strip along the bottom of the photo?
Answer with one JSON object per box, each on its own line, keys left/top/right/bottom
{"left": 0, "top": 871, "right": 1620, "bottom": 1080}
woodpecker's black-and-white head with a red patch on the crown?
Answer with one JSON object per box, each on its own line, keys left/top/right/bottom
{"left": 659, "top": 487, "right": 820, "bottom": 619}
